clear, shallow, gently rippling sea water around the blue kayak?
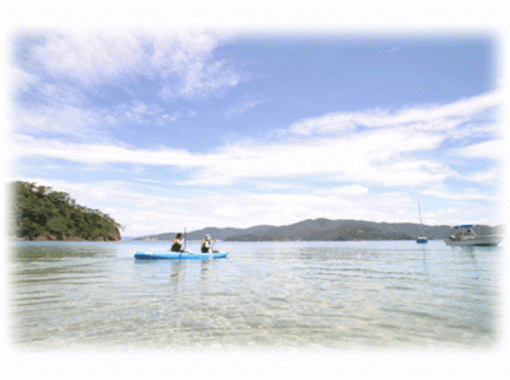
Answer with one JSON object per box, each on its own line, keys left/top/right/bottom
{"left": 8, "top": 241, "right": 503, "bottom": 350}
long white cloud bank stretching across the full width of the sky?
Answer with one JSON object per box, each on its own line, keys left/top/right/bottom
{"left": 14, "top": 93, "right": 503, "bottom": 190}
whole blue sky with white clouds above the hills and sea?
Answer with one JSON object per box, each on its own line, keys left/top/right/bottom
{"left": 9, "top": 30, "right": 503, "bottom": 236}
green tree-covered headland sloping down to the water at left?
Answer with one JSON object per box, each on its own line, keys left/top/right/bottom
{"left": 10, "top": 181, "right": 121, "bottom": 241}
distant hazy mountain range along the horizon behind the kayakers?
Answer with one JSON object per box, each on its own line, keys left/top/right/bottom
{"left": 134, "top": 218, "right": 503, "bottom": 241}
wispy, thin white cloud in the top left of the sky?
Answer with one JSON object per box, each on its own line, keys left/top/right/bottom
{"left": 25, "top": 33, "right": 246, "bottom": 98}
